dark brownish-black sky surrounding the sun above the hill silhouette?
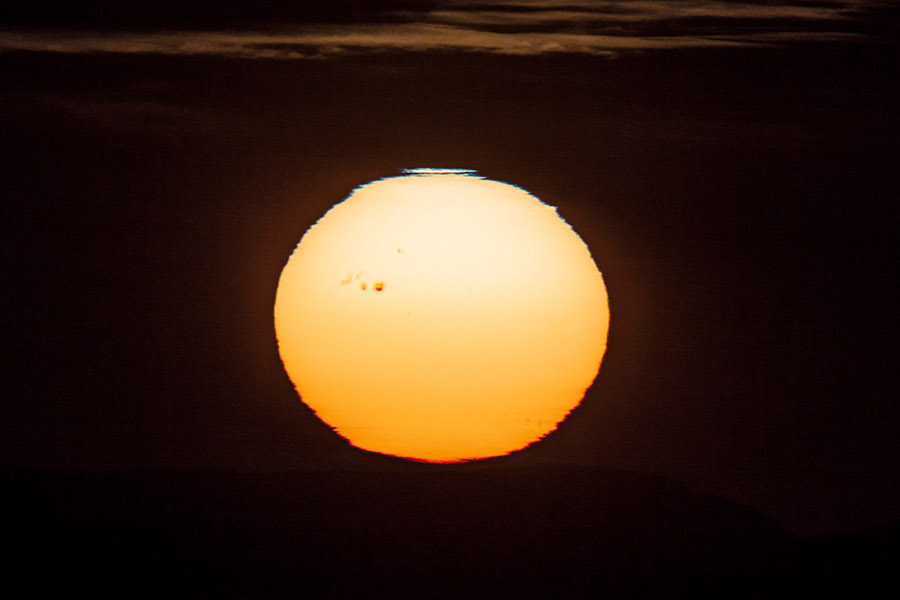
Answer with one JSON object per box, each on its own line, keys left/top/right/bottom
{"left": 0, "top": 0, "right": 900, "bottom": 530}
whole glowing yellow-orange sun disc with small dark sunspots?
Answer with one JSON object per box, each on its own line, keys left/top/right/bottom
{"left": 275, "top": 169, "right": 609, "bottom": 462}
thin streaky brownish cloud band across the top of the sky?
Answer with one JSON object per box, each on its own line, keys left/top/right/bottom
{"left": 0, "top": 0, "right": 883, "bottom": 59}
